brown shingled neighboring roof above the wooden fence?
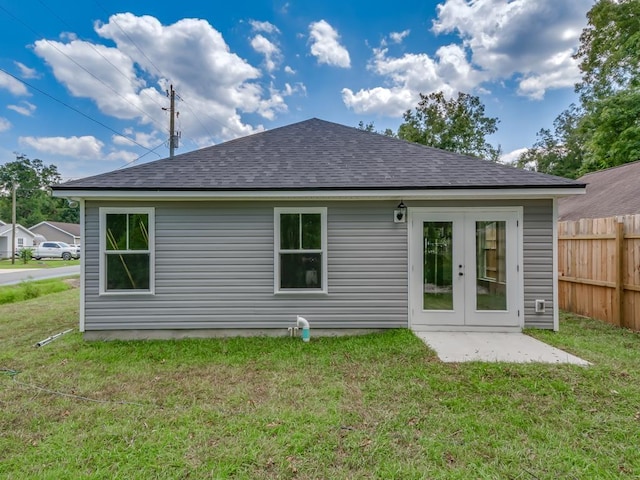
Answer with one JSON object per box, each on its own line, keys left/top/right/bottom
{"left": 558, "top": 160, "right": 640, "bottom": 221}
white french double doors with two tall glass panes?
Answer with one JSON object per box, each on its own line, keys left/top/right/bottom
{"left": 409, "top": 208, "right": 522, "bottom": 330}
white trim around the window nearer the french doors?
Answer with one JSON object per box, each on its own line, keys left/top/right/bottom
{"left": 273, "top": 207, "right": 329, "bottom": 295}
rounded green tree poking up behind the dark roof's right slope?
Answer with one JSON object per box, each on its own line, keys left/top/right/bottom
{"left": 398, "top": 92, "right": 501, "bottom": 161}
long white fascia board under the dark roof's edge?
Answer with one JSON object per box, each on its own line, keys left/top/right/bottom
{"left": 54, "top": 187, "right": 586, "bottom": 201}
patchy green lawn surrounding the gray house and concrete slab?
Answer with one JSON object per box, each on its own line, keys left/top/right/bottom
{"left": 0, "top": 289, "right": 640, "bottom": 479}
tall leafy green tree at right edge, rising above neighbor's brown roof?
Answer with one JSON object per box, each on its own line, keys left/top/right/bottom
{"left": 575, "top": 0, "right": 640, "bottom": 173}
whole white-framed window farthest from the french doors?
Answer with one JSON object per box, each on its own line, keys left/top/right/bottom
{"left": 100, "top": 208, "right": 155, "bottom": 293}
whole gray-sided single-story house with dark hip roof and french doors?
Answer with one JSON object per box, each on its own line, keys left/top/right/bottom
{"left": 53, "top": 119, "right": 584, "bottom": 339}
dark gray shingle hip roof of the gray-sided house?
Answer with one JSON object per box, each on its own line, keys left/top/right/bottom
{"left": 54, "top": 118, "right": 583, "bottom": 191}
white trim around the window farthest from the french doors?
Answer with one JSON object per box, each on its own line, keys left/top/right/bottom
{"left": 99, "top": 207, "right": 156, "bottom": 295}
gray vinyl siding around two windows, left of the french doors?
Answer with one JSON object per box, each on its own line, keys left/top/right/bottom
{"left": 84, "top": 202, "right": 408, "bottom": 330}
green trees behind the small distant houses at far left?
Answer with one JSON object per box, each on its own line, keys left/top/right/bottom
{"left": 0, "top": 155, "right": 79, "bottom": 228}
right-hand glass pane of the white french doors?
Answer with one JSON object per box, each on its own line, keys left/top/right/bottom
{"left": 476, "top": 221, "right": 507, "bottom": 310}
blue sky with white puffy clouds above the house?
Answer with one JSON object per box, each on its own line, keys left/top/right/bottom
{"left": 0, "top": 0, "right": 594, "bottom": 179}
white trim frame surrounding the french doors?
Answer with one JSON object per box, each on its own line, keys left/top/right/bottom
{"left": 407, "top": 206, "right": 524, "bottom": 332}
